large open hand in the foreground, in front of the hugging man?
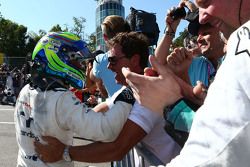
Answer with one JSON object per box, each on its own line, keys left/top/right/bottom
{"left": 122, "top": 56, "right": 182, "bottom": 113}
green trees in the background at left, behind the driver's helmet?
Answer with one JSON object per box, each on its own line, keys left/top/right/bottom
{"left": 0, "top": 14, "right": 96, "bottom": 67}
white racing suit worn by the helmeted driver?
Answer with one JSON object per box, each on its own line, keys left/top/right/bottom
{"left": 14, "top": 85, "right": 132, "bottom": 167}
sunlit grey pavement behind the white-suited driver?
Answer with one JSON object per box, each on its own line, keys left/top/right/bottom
{"left": 0, "top": 105, "right": 110, "bottom": 167}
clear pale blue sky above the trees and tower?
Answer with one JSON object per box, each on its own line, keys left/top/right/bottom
{"left": 0, "top": 0, "right": 187, "bottom": 37}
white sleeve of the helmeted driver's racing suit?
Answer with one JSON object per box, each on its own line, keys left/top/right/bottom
{"left": 56, "top": 93, "right": 132, "bottom": 142}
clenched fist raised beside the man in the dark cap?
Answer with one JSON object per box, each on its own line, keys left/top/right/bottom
{"left": 166, "top": 47, "right": 193, "bottom": 83}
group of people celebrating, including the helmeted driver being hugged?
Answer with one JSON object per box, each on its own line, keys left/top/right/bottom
{"left": 10, "top": 0, "right": 250, "bottom": 167}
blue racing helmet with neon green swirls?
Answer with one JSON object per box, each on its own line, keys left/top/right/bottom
{"left": 32, "top": 32, "right": 94, "bottom": 89}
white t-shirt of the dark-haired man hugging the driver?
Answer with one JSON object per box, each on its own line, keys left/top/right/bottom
{"left": 107, "top": 86, "right": 181, "bottom": 163}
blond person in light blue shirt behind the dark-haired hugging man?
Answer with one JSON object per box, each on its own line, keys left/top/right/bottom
{"left": 90, "top": 15, "right": 130, "bottom": 97}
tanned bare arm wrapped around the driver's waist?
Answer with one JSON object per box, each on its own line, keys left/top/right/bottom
{"left": 69, "top": 119, "right": 146, "bottom": 163}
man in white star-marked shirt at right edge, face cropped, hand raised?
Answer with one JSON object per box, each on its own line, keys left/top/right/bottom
{"left": 123, "top": 0, "right": 250, "bottom": 167}
